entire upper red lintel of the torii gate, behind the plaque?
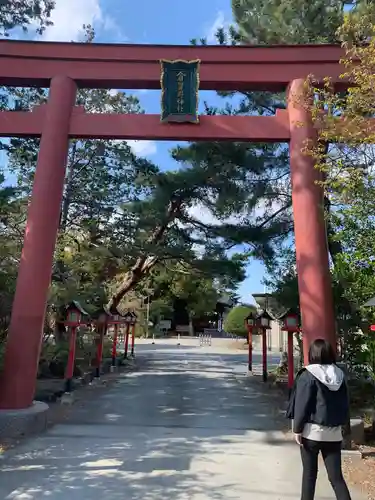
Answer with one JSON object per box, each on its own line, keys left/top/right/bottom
{"left": 0, "top": 40, "right": 343, "bottom": 90}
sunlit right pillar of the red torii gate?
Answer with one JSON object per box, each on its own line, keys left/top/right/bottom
{"left": 288, "top": 79, "right": 336, "bottom": 363}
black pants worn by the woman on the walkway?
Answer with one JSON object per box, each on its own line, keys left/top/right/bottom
{"left": 301, "top": 439, "right": 351, "bottom": 500}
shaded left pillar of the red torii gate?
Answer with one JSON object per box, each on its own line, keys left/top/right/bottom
{"left": 0, "top": 76, "right": 76, "bottom": 409}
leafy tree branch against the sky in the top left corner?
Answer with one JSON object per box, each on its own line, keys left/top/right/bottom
{"left": 0, "top": 0, "right": 55, "bottom": 36}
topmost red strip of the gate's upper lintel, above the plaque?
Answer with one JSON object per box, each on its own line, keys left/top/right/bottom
{"left": 0, "top": 39, "right": 344, "bottom": 64}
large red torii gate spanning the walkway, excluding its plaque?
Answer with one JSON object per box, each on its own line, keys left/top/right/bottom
{"left": 0, "top": 40, "right": 343, "bottom": 409}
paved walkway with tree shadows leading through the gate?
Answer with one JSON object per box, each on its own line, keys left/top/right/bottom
{"left": 0, "top": 344, "right": 361, "bottom": 500}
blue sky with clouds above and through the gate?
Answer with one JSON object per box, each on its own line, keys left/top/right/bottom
{"left": 5, "top": 0, "right": 270, "bottom": 302}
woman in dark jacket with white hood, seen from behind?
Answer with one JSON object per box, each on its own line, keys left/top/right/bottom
{"left": 287, "top": 339, "right": 350, "bottom": 500}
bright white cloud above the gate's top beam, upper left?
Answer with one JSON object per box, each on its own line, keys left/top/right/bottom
{"left": 38, "top": 0, "right": 120, "bottom": 42}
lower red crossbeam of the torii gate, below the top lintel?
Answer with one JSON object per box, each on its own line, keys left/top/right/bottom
{"left": 0, "top": 106, "right": 289, "bottom": 142}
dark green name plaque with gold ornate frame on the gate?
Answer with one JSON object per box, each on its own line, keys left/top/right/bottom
{"left": 160, "top": 59, "right": 200, "bottom": 123}
